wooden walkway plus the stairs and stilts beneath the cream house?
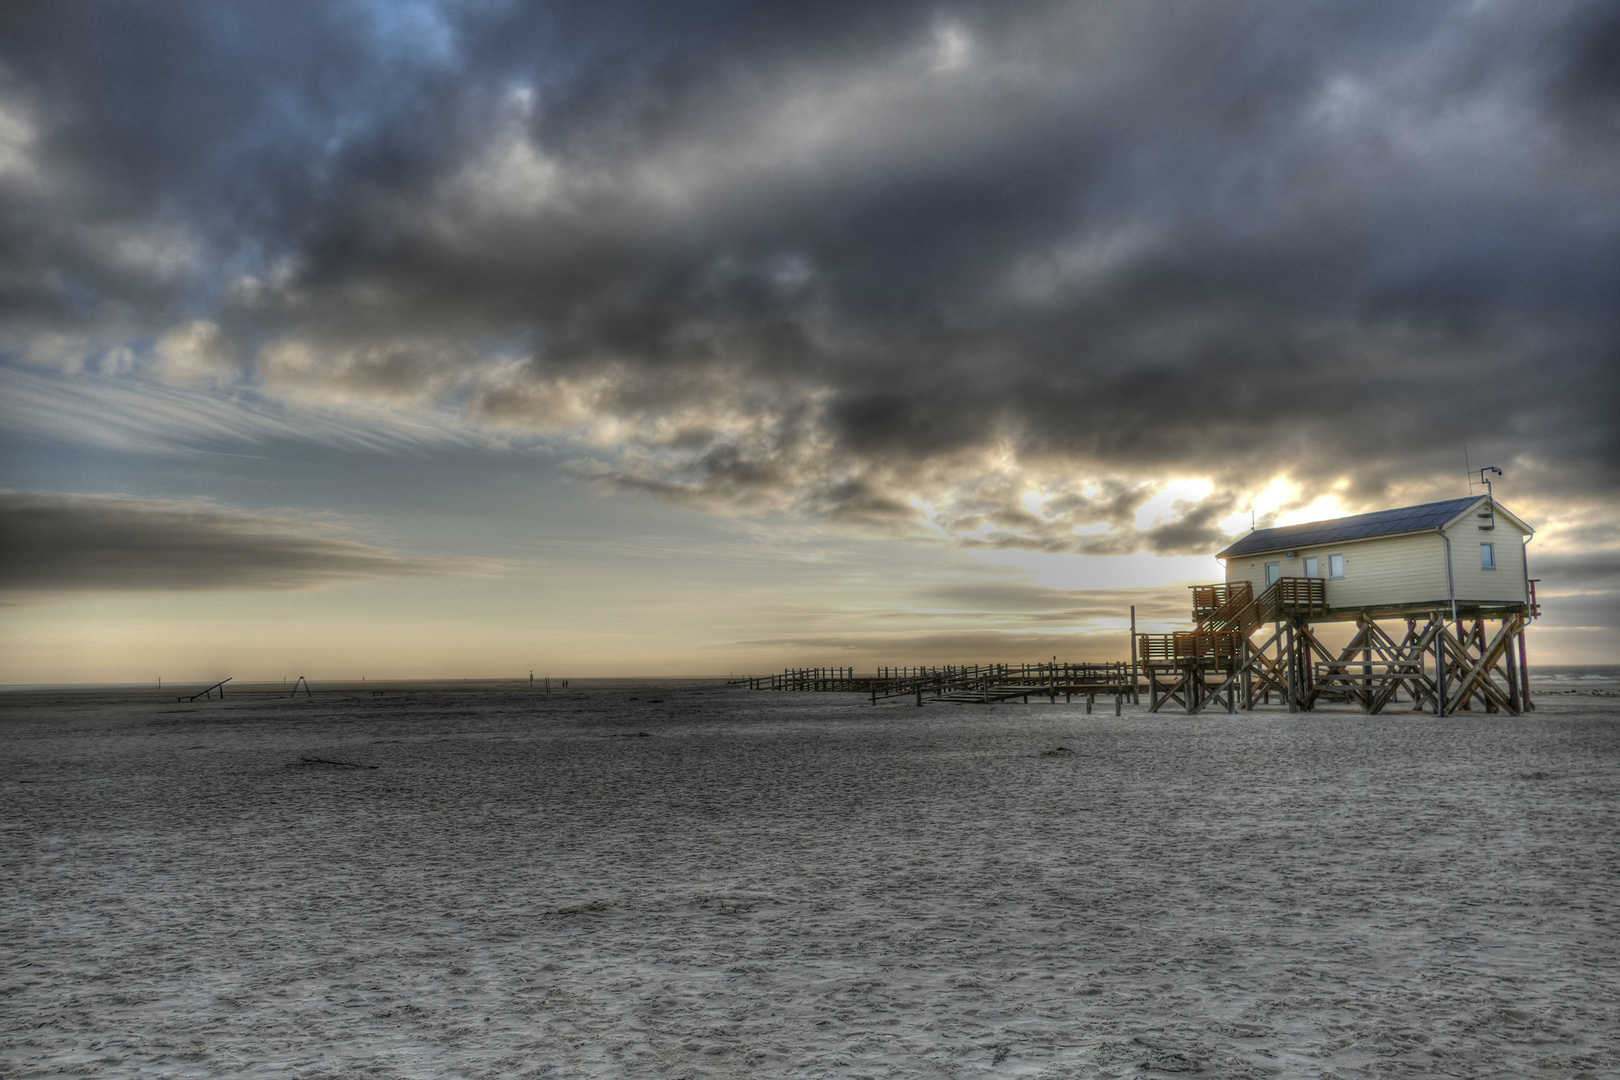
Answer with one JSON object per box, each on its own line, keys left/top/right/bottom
{"left": 731, "top": 578, "right": 1539, "bottom": 716}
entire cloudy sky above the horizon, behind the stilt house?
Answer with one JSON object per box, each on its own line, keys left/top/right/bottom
{"left": 0, "top": 0, "right": 1620, "bottom": 682}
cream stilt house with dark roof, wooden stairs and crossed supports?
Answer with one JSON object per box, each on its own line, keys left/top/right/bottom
{"left": 1137, "top": 495, "right": 1539, "bottom": 716}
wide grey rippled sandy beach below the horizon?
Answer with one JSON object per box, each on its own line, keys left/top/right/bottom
{"left": 0, "top": 685, "right": 1620, "bottom": 1078}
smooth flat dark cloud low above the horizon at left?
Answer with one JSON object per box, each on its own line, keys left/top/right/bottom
{"left": 0, "top": 492, "right": 468, "bottom": 593}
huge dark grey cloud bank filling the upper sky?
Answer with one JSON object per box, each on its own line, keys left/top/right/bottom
{"left": 0, "top": 2, "right": 1620, "bottom": 554}
